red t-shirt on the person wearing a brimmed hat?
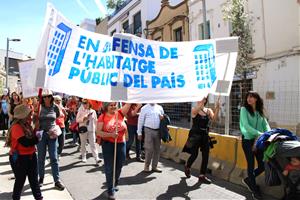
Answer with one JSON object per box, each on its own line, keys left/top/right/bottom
{"left": 9, "top": 124, "right": 35, "bottom": 155}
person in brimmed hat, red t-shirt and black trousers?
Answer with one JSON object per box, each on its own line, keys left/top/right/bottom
{"left": 7, "top": 104, "right": 43, "bottom": 200}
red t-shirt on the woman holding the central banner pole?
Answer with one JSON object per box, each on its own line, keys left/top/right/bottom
{"left": 98, "top": 110, "right": 127, "bottom": 143}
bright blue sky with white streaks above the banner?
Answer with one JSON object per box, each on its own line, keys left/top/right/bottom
{"left": 0, "top": 0, "right": 107, "bottom": 58}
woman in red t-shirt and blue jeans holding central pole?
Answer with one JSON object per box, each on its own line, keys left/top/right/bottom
{"left": 96, "top": 102, "right": 130, "bottom": 199}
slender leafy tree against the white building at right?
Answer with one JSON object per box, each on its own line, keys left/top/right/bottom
{"left": 222, "top": 0, "right": 257, "bottom": 79}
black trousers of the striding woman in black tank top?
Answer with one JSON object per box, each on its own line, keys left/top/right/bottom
{"left": 186, "top": 135, "right": 209, "bottom": 175}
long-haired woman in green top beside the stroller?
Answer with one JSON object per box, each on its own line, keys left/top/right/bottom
{"left": 240, "top": 91, "right": 271, "bottom": 199}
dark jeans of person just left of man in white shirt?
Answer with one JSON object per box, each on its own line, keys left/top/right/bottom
{"left": 126, "top": 124, "right": 141, "bottom": 158}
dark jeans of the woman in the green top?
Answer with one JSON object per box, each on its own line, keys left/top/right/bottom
{"left": 242, "top": 139, "right": 265, "bottom": 191}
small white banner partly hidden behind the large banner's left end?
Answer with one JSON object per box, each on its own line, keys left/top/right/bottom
{"left": 19, "top": 60, "right": 38, "bottom": 98}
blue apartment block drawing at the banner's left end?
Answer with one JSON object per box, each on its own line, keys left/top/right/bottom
{"left": 47, "top": 23, "right": 72, "bottom": 76}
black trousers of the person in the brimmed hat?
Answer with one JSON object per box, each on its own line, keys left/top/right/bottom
{"left": 9, "top": 153, "right": 43, "bottom": 200}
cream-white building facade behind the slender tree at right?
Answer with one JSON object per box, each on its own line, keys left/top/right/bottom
{"left": 188, "top": 0, "right": 300, "bottom": 134}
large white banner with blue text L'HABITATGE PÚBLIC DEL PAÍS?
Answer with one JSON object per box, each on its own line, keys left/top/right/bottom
{"left": 37, "top": 3, "right": 237, "bottom": 103}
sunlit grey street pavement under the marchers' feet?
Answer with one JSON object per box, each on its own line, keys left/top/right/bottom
{"left": 0, "top": 135, "right": 274, "bottom": 200}
